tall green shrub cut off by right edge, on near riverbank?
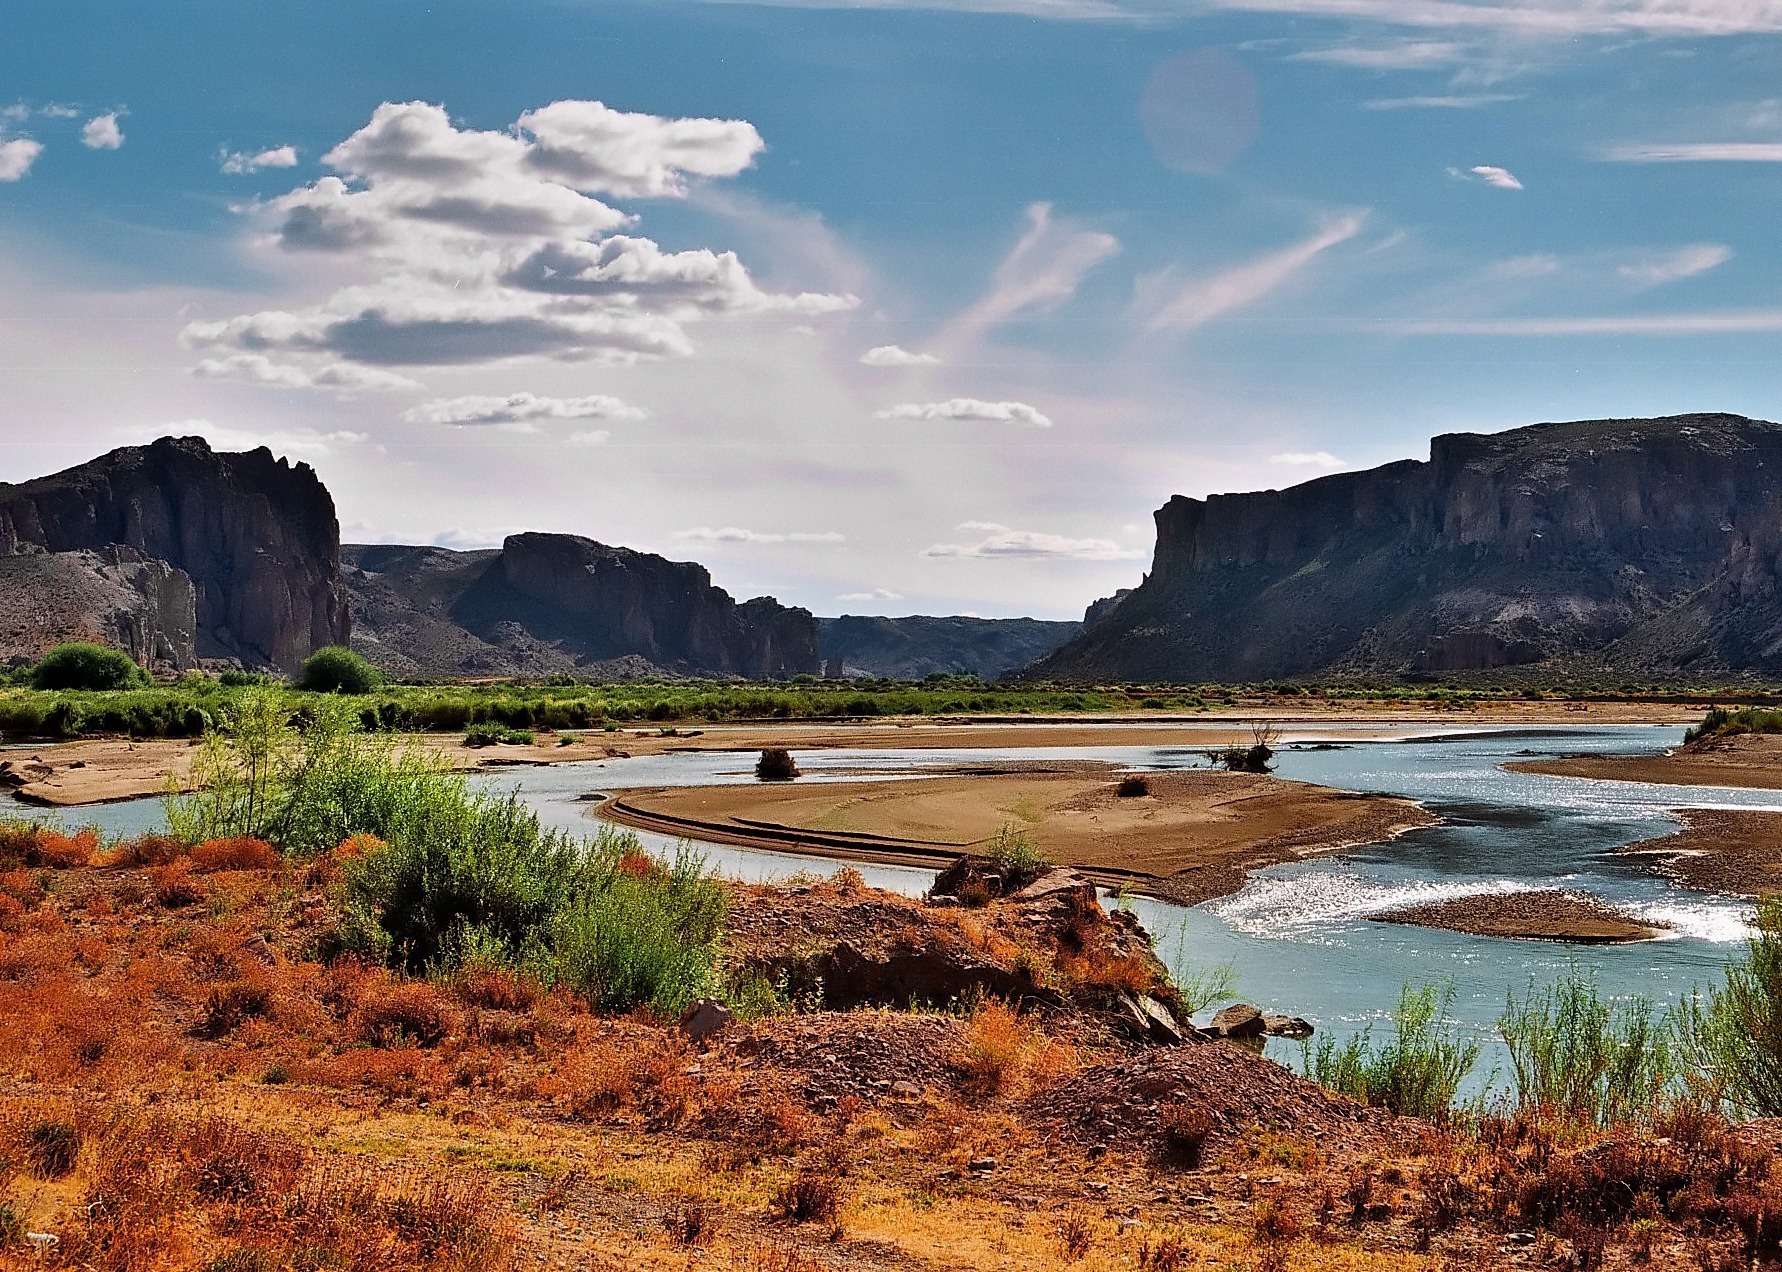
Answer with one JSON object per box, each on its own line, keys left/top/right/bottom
{"left": 1677, "top": 896, "right": 1782, "bottom": 1117}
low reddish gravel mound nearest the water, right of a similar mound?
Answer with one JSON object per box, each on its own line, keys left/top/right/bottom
{"left": 1026, "top": 1042, "right": 1399, "bottom": 1153}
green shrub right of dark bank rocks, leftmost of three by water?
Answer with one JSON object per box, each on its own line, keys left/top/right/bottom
{"left": 1303, "top": 983, "right": 1479, "bottom": 1121}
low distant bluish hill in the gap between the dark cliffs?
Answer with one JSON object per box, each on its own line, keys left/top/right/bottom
{"left": 816, "top": 615, "right": 1083, "bottom": 681}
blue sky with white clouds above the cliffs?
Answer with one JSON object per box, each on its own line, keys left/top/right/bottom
{"left": 0, "top": 0, "right": 1782, "bottom": 618}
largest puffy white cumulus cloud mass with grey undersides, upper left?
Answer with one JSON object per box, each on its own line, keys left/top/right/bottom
{"left": 182, "top": 102, "right": 855, "bottom": 375}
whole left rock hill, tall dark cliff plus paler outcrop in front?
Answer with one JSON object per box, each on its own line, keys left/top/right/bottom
{"left": 0, "top": 436, "right": 349, "bottom": 670}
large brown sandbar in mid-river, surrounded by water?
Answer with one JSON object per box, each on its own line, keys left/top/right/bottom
{"left": 601, "top": 764, "right": 1438, "bottom": 905}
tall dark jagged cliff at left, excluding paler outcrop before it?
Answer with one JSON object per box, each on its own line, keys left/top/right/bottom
{"left": 0, "top": 436, "right": 351, "bottom": 670}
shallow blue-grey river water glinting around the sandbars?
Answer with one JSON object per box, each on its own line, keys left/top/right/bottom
{"left": 20, "top": 725, "right": 1782, "bottom": 1078}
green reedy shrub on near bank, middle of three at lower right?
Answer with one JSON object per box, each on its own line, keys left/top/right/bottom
{"left": 1497, "top": 969, "right": 1677, "bottom": 1126}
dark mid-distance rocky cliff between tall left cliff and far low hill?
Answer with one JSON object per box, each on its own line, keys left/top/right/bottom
{"left": 342, "top": 534, "right": 818, "bottom": 679}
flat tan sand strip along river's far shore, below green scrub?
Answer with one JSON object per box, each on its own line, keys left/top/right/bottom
{"left": 0, "top": 702, "right": 1689, "bottom": 807}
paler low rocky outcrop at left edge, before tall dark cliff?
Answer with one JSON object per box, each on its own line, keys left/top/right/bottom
{"left": 0, "top": 545, "right": 198, "bottom": 672}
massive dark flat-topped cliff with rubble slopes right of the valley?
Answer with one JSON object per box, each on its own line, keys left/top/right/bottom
{"left": 1034, "top": 415, "right": 1782, "bottom": 681}
